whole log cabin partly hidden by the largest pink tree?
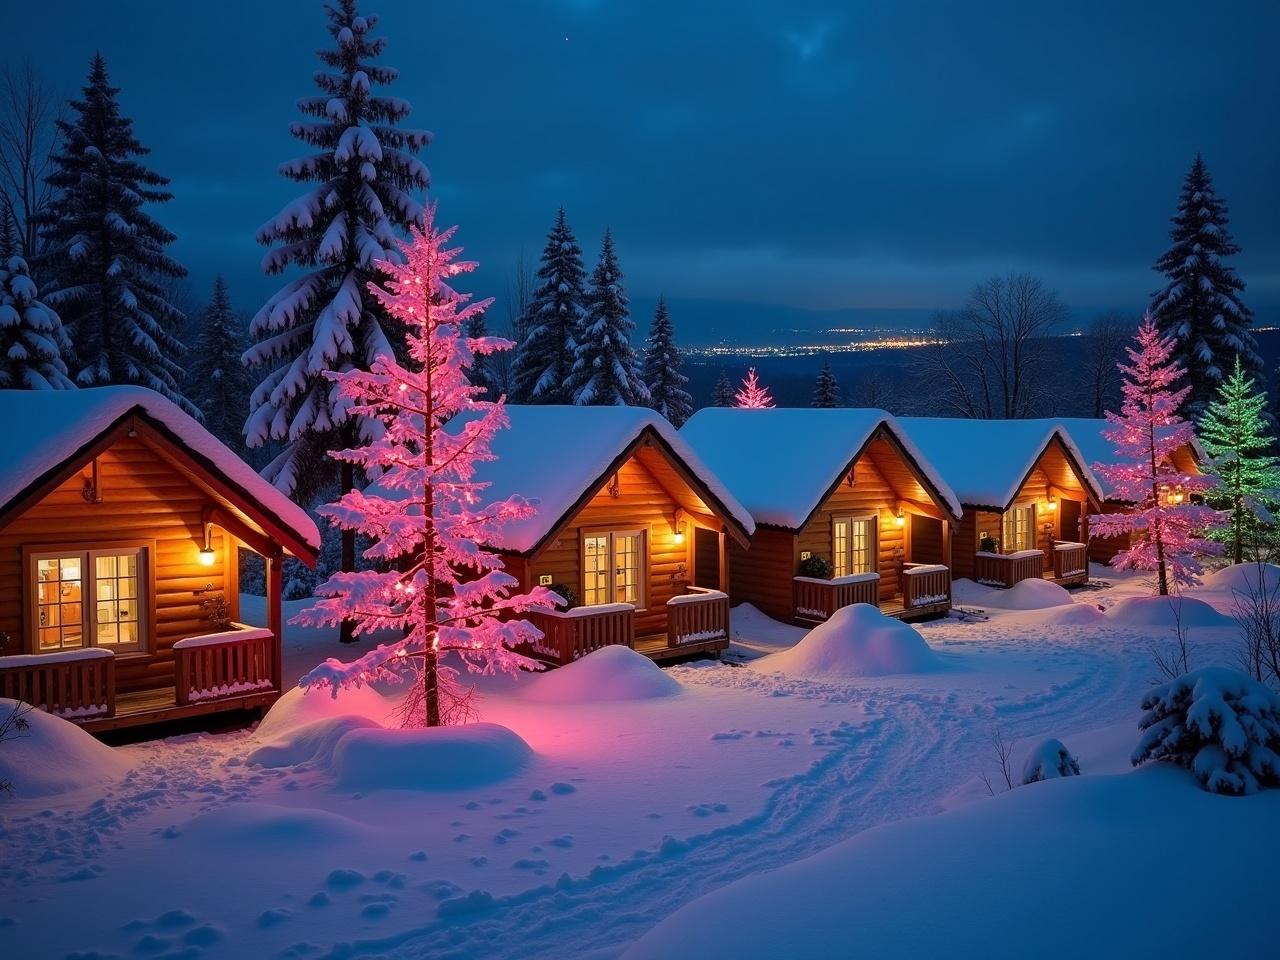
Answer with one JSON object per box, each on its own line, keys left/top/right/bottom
{"left": 476, "top": 406, "right": 754, "bottom": 664}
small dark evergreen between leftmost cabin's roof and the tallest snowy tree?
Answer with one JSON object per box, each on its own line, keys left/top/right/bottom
{"left": 187, "top": 276, "right": 253, "bottom": 451}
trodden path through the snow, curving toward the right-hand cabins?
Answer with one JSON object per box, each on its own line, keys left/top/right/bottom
{"left": 324, "top": 622, "right": 1149, "bottom": 960}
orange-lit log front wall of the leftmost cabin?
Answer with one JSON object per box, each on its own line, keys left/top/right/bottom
{"left": 0, "top": 438, "right": 238, "bottom": 692}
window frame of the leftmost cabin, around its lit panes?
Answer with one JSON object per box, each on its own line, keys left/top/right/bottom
{"left": 22, "top": 540, "right": 156, "bottom": 658}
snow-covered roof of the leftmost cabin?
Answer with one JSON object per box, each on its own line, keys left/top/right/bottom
{"left": 0, "top": 387, "right": 320, "bottom": 549}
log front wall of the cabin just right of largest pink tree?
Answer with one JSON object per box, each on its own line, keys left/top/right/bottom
{"left": 529, "top": 456, "right": 694, "bottom": 636}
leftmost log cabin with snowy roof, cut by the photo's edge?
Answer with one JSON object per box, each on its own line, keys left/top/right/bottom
{"left": 0, "top": 387, "right": 320, "bottom": 731}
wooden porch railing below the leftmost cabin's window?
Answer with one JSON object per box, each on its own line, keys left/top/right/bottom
{"left": 0, "top": 648, "right": 115, "bottom": 721}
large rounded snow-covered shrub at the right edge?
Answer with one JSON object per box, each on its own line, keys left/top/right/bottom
{"left": 1132, "top": 667, "right": 1280, "bottom": 794}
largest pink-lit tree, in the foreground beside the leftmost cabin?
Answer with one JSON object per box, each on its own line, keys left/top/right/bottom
{"left": 302, "top": 206, "right": 558, "bottom": 727}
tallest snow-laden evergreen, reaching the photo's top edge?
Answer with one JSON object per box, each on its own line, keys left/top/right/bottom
{"left": 244, "top": 0, "right": 431, "bottom": 504}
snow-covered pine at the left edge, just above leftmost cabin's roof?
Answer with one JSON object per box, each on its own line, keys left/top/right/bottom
{"left": 0, "top": 244, "right": 76, "bottom": 390}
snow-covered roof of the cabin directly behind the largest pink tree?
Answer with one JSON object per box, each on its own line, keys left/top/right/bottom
{"left": 476, "top": 404, "right": 755, "bottom": 553}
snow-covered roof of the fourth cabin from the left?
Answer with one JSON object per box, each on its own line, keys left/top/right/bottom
{"left": 901, "top": 417, "right": 1102, "bottom": 509}
